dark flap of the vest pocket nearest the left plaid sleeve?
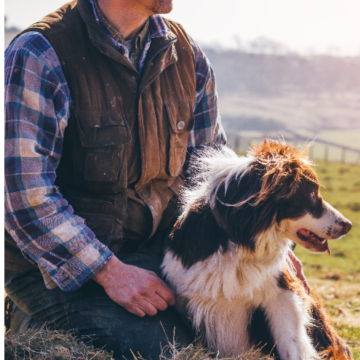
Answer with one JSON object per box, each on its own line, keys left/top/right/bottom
{"left": 76, "top": 112, "right": 131, "bottom": 147}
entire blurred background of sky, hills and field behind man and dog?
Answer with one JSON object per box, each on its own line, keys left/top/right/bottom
{"left": 5, "top": 0, "right": 360, "bottom": 359}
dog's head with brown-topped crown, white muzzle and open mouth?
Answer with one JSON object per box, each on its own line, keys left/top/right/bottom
{"left": 188, "top": 140, "right": 352, "bottom": 253}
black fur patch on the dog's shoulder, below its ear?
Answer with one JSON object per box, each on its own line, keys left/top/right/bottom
{"left": 168, "top": 204, "right": 228, "bottom": 268}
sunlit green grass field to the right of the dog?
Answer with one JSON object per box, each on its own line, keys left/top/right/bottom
{"left": 295, "top": 162, "right": 360, "bottom": 359}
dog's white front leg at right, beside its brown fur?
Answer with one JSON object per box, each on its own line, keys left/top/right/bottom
{"left": 263, "top": 289, "right": 320, "bottom": 360}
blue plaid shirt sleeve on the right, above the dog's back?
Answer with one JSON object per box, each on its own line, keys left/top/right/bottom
{"left": 184, "top": 37, "right": 226, "bottom": 172}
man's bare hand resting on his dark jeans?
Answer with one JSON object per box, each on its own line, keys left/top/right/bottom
{"left": 92, "top": 255, "right": 175, "bottom": 317}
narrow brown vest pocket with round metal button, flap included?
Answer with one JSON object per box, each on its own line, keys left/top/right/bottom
{"left": 165, "top": 101, "right": 194, "bottom": 177}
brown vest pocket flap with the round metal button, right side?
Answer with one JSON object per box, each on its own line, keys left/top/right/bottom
{"left": 165, "top": 101, "right": 194, "bottom": 134}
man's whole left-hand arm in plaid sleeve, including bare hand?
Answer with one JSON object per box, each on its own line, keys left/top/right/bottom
{"left": 5, "top": 33, "right": 175, "bottom": 316}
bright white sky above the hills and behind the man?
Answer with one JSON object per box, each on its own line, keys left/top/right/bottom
{"left": 5, "top": 0, "right": 360, "bottom": 55}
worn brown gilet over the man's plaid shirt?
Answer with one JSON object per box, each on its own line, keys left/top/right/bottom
{"left": 6, "top": 0, "right": 196, "bottom": 271}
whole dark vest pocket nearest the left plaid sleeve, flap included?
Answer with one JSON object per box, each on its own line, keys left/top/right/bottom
{"left": 76, "top": 112, "right": 131, "bottom": 188}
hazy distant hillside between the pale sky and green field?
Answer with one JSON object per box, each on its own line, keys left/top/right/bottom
{"left": 205, "top": 49, "right": 360, "bottom": 135}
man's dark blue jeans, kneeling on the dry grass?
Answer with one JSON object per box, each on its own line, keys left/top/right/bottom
{"left": 5, "top": 231, "right": 194, "bottom": 360}
